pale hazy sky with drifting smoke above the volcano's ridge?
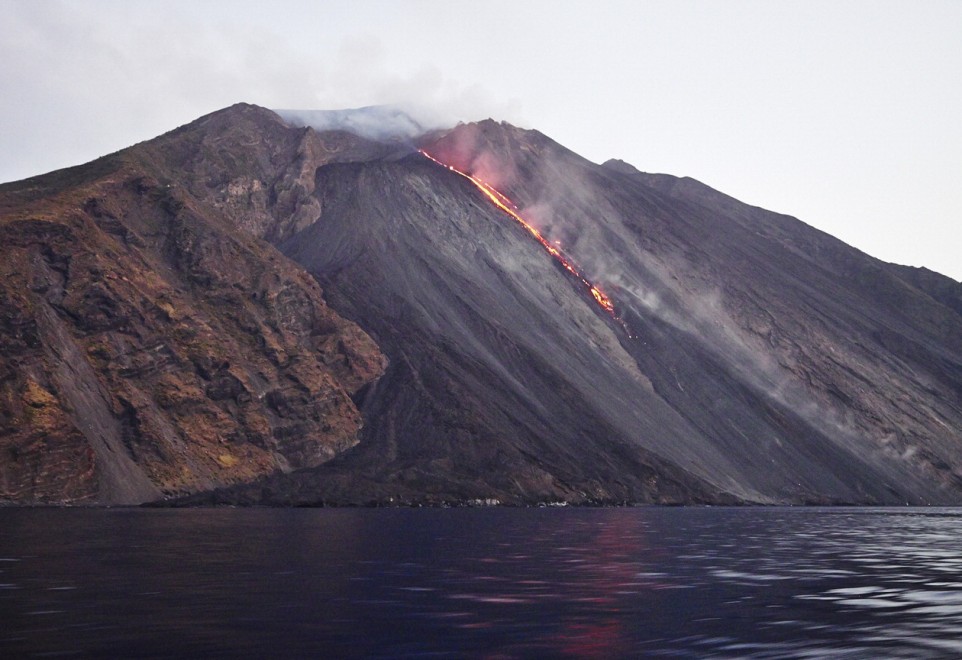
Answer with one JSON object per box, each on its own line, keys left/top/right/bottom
{"left": 0, "top": 0, "right": 962, "bottom": 280}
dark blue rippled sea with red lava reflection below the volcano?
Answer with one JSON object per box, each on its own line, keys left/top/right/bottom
{"left": 0, "top": 508, "right": 962, "bottom": 658}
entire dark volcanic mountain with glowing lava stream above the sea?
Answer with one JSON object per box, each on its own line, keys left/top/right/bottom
{"left": 0, "top": 104, "right": 962, "bottom": 505}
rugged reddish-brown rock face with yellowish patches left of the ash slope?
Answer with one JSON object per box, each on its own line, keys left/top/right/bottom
{"left": 0, "top": 105, "right": 384, "bottom": 503}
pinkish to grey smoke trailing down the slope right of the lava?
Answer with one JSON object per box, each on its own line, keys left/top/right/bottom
{"left": 428, "top": 124, "right": 900, "bottom": 472}
